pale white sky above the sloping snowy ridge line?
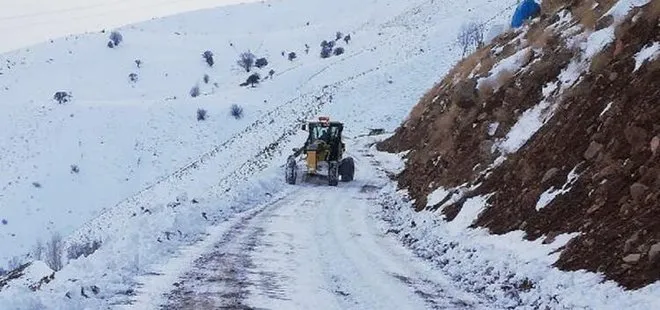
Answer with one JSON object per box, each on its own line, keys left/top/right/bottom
{"left": 0, "top": 0, "right": 255, "bottom": 52}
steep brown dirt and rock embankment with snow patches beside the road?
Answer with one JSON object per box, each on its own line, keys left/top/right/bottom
{"left": 379, "top": 1, "right": 660, "bottom": 289}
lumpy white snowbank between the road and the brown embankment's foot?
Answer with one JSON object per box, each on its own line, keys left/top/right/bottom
{"left": 376, "top": 149, "right": 660, "bottom": 310}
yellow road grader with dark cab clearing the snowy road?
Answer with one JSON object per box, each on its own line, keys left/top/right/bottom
{"left": 285, "top": 117, "right": 355, "bottom": 186}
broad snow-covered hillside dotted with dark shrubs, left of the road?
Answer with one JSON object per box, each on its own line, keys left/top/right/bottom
{"left": 0, "top": 0, "right": 515, "bottom": 308}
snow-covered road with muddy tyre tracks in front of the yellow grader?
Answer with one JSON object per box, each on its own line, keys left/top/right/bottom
{"left": 158, "top": 173, "right": 480, "bottom": 309}
